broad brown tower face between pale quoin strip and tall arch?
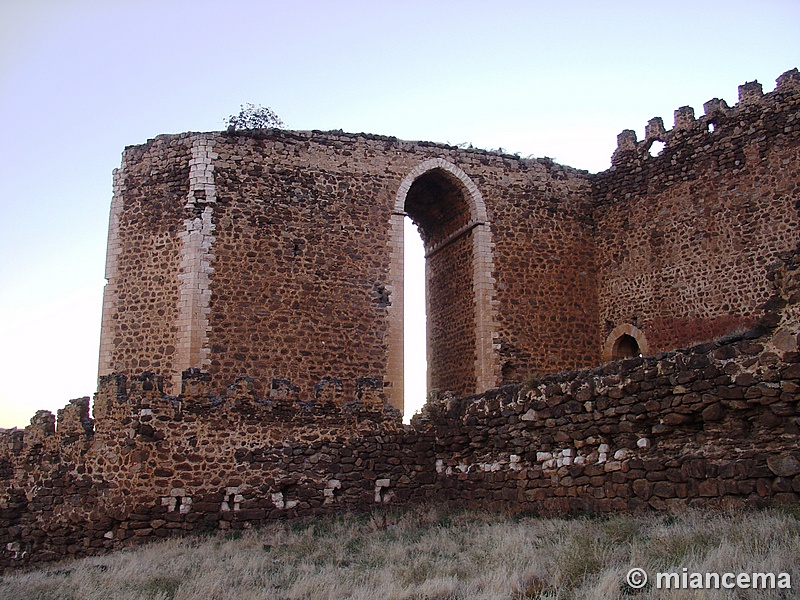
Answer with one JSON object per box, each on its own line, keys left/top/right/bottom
{"left": 209, "top": 134, "right": 392, "bottom": 408}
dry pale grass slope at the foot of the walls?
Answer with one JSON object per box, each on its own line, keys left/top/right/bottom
{"left": 0, "top": 508, "right": 800, "bottom": 600}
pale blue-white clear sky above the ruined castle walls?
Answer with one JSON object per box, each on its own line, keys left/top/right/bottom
{"left": 0, "top": 0, "right": 800, "bottom": 427}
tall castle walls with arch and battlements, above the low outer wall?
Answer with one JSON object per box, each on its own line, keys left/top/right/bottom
{"left": 100, "top": 69, "right": 800, "bottom": 409}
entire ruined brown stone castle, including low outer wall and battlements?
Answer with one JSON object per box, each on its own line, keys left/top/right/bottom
{"left": 0, "top": 69, "right": 800, "bottom": 568}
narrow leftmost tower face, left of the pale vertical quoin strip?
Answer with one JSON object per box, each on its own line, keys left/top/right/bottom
{"left": 99, "top": 134, "right": 190, "bottom": 375}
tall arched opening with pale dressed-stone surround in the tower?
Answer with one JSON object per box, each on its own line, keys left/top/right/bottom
{"left": 388, "top": 159, "right": 498, "bottom": 406}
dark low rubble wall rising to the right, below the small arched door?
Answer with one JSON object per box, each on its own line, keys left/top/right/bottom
{"left": 423, "top": 244, "right": 800, "bottom": 513}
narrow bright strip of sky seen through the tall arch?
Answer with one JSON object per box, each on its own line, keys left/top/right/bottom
{"left": 403, "top": 217, "right": 428, "bottom": 423}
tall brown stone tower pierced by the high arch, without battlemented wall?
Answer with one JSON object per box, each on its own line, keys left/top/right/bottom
{"left": 101, "top": 131, "right": 598, "bottom": 408}
